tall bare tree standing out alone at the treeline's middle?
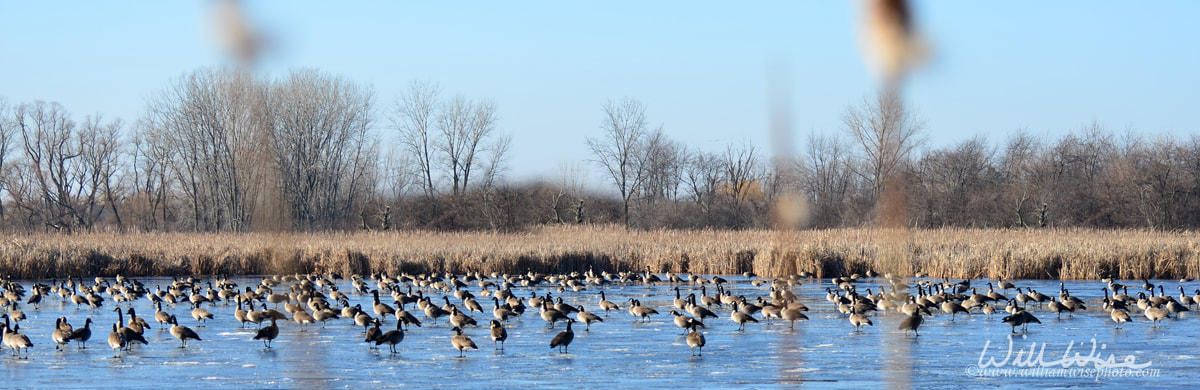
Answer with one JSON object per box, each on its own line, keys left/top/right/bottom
{"left": 587, "top": 97, "right": 648, "bottom": 228}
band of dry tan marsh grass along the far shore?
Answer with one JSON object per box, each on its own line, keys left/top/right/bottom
{"left": 0, "top": 227, "right": 1200, "bottom": 280}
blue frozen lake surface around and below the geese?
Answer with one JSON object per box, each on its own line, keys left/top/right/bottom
{"left": 0, "top": 276, "right": 1200, "bottom": 389}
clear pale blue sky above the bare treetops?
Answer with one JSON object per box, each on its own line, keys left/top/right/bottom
{"left": 0, "top": 1, "right": 1200, "bottom": 181}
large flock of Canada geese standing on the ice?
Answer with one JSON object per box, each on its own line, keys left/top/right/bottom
{"left": 0, "top": 269, "right": 1200, "bottom": 359}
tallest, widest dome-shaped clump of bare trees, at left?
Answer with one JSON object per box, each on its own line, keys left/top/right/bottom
{"left": 131, "top": 68, "right": 378, "bottom": 232}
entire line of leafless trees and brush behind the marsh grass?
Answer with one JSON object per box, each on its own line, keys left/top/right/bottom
{"left": 0, "top": 68, "right": 1200, "bottom": 233}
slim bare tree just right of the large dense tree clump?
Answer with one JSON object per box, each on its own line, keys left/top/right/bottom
{"left": 391, "top": 82, "right": 440, "bottom": 199}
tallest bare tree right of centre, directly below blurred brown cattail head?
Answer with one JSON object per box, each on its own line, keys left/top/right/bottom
{"left": 842, "top": 89, "right": 925, "bottom": 197}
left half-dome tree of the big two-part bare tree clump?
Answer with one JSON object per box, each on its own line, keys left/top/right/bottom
{"left": 143, "top": 68, "right": 266, "bottom": 232}
